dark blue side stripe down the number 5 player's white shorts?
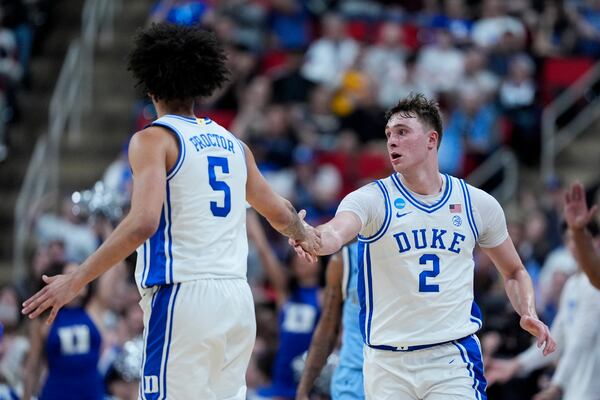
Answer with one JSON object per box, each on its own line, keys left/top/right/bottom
{"left": 141, "top": 285, "right": 173, "bottom": 400}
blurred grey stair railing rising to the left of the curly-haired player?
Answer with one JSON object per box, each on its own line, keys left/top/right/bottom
{"left": 13, "top": 0, "right": 121, "bottom": 282}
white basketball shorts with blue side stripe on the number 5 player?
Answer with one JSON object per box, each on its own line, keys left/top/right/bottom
{"left": 139, "top": 279, "right": 256, "bottom": 400}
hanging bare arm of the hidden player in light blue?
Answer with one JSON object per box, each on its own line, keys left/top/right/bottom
{"left": 296, "top": 253, "right": 343, "bottom": 400}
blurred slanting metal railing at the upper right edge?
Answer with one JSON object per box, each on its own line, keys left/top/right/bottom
{"left": 540, "top": 62, "right": 600, "bottom": 180}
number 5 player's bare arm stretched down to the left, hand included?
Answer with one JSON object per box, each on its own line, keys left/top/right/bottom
{"left": 23, "top": 128, "right": 171, "bottom": 323}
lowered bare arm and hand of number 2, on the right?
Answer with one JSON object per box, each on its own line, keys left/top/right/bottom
{"left": 482, "top": 237, "right": 556, "bottom": 355}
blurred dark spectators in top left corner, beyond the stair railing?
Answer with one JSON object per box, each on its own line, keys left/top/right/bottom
{"left": 0, "top": 0, "right": 52, "bottom": 161}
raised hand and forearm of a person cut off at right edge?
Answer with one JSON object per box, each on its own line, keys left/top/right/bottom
{"left": 564, "top": 183, "right": 600, "bottom": 289}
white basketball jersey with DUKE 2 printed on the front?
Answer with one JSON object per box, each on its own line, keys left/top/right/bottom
{"left": 358, "top": 174, "right": 481, "bottom": 350}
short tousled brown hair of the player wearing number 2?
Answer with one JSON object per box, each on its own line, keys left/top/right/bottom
{"left": 385, "top": 93, "right": 443, "bottom": 149}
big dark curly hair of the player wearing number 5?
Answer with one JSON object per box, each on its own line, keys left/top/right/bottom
{"left": 127, "top": 23, "right": 229, "bottom": 102}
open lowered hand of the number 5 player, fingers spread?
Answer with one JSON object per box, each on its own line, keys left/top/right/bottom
{"left": 21, "top": 271, "right": 85, "bottom": 325}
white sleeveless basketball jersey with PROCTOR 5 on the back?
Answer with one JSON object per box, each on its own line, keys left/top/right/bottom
{"left": 135, "top": 115, "right": 248, "bottom": 288}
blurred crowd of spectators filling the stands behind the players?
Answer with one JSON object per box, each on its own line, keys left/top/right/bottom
{"left": 0, "top": 0, "right": 600, "bottom": 400}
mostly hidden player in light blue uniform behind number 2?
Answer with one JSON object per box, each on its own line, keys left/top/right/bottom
{"left": 296, "top": 243, "right": 365, "bottom": 400}
